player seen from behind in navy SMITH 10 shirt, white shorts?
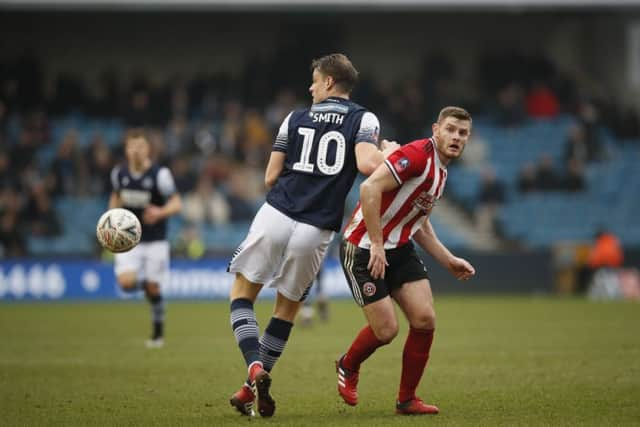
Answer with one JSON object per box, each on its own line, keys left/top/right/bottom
{"left": 228, "top": 54, "right": 397, "bottom": 417}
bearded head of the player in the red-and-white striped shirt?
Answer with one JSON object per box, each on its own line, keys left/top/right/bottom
{"left": 432, "top": 107, "right": 471, "bottom": 165}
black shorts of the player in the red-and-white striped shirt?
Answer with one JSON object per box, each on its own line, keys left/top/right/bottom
{"left": 340, "top": 239, "right": 429, "bottom": 307}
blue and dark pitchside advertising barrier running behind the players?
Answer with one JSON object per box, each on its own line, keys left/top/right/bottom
{"left": 0, "top": 251, "right": 553, "bottom": 301}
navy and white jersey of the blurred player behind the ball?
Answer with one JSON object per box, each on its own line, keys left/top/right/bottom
{"left": 111, "top": 164, "right": 176, "bottom": 242}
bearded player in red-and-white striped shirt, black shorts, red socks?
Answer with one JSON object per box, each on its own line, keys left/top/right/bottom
{"left": 336, "top": 107, "right": 475, "bottom": 415}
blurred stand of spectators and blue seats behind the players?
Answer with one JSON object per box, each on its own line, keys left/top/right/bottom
{"left": 0, "top": 10, "right": 640, "bottom": 268}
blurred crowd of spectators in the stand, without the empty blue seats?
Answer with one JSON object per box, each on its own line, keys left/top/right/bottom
{"left": 0, "top": 53, "right": 640, "bottom": 256}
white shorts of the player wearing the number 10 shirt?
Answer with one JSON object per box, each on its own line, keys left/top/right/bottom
{"left": 228, "top": 203, "right": 334, "bottom": 301}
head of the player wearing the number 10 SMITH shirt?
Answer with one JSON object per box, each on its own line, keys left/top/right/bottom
{"left": 309, "top": 53, "right": 358, "bottom": 104}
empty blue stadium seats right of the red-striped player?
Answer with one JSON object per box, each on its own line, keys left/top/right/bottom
{"left": 448, "top": 116, "right": 640, "bottom": 247}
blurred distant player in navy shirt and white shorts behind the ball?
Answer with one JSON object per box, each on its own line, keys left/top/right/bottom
{"left": 109, "top": 130, "right": 182, "bottom": 348}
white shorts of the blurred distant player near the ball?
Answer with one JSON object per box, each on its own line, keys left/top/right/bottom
{"left": 114, "top": 240, "right": 169, "bottom": 286}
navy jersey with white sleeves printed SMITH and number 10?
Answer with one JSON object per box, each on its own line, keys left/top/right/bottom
{"left": 267, "top": 97, "right": 380, "bottom": 231}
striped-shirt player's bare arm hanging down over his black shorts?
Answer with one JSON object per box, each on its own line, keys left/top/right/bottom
{"left": 360, "top": 165, "right": 399, "bottom": 279}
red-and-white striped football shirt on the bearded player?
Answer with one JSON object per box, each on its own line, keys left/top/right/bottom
{"left": 344, "top": 138, "right": 447, "bottom": 249}
